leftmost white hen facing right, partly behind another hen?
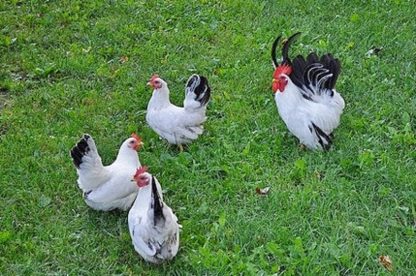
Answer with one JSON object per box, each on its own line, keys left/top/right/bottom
{"left": 71, "top": 134, "right": 143, "bottom": 211}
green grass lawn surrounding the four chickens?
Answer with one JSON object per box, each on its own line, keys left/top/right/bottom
{"left": 0, "top": 0, "right": 416, "bottom": 275}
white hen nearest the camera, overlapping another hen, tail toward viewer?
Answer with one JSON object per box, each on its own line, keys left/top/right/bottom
{"left": 128, "top": 167, "right": 180, "bottom": 264}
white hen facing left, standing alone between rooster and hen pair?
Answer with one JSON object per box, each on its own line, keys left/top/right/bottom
{"left": 146, "top": 74, "right": 211, "bottom": 151}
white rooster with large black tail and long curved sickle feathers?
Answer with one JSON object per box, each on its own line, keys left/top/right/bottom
{"left": 272, "top": 33, "right": 345, "bottom": 150}
